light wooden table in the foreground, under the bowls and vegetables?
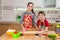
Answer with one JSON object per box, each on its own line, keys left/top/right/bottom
{"left": 0, "top": 31, "right": 53, "bottom": 40}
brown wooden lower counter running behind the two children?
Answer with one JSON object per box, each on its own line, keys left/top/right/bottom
{"left": 0, "top": 21, "right": 56, "bottom": 36}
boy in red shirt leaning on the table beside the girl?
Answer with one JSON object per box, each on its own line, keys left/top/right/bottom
{"left": 37, "top": 11, "right": 49, "bottom": 31}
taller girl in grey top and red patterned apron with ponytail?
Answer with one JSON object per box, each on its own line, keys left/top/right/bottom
{"left": 20, "top": 2, "right": 35, "bottom": 31}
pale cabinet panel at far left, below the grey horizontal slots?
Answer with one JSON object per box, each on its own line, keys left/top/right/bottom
{"left": 3, "top": 10, "right": 16, "bottom": 21}
